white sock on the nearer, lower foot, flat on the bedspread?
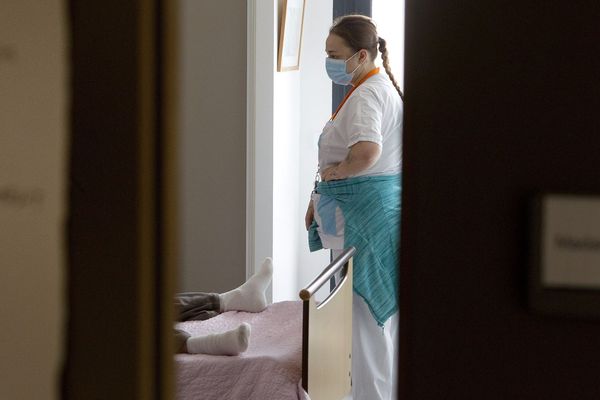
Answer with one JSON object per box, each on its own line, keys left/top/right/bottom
{"left": 186, "top": 322, "right": 250, "bottom": 356}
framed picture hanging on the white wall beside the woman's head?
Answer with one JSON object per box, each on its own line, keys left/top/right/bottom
{"left": 277, "top": 0, "right": 306, "bottom": 72}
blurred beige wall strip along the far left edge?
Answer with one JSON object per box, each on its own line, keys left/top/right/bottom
{"left": 0, "top": 0, "right": 68, "bottom": 400}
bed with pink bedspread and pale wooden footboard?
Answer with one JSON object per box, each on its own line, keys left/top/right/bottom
{"left": 175, "top": 248, "right": 355, "bottom": 400}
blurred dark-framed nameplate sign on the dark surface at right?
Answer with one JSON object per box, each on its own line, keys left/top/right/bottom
{"left": 528, "top": 193, "right": 600, "bottom": 319}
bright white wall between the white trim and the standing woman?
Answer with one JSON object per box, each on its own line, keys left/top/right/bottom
{"left": 273, "top": 0, "right": 333, "bottom": 301}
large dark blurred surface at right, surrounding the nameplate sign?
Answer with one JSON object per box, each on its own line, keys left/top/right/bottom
{"left": 400, "top": 0, "right": 600, "bottom": 400}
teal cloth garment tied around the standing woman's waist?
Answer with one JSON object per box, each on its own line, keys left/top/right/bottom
{"left": 308, "top": 175, "right": 401, "bottom": 326}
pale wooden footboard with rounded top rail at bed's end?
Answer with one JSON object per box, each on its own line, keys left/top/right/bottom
{"left": 300, "top": 247, "right": 356, "bottom": 400}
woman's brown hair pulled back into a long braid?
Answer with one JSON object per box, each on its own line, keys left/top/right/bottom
{"left": 329, "top": 14, "right": 404, "bottom": 100}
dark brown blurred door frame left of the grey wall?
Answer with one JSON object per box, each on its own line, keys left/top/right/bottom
{"left": 66, "top": 0, "right": 176, "bottom": 400}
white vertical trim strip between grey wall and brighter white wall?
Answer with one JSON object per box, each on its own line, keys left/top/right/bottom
{"left": 246, "top": 0, "right": 278, "bottom": 298}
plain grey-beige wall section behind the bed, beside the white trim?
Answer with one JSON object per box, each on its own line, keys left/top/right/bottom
{"left": 179, "top": 0, "right": 246, "bottom": 291}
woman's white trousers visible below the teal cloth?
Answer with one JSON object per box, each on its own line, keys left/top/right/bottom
{"left": 333, "top": 250, "right": 399, "bottom": 400}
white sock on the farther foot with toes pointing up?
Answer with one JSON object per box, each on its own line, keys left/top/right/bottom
{"left": 219, "top": 257, "right": 273, "bottom": 312}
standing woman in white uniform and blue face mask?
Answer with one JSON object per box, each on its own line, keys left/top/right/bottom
{"left": 305, "top": 15, "right": 403, "bottom": 400}
